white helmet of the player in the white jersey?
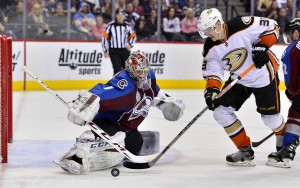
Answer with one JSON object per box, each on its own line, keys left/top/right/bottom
{"left": 198, "top": 8, "right": 224, "bottom": 38}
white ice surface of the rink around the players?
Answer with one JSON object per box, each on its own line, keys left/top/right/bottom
{"left": 0, "top": 90, "right": 300, "bottom": 188}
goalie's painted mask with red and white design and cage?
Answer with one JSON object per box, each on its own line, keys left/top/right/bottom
{"left": 125, "top": 51, "right": 150, "bottom": 82}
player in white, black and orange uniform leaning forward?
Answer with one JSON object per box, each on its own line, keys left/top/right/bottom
{"left": 198, "top": 8, "right": 285, "bottom": 166}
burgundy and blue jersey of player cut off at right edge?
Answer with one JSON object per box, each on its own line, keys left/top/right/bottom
{"left": 281, "top": 39, "right": 300, "bottom": 99}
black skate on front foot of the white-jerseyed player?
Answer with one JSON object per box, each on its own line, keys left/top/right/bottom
{"left": 226, "top": 145, "right": 255, "bottom": 166}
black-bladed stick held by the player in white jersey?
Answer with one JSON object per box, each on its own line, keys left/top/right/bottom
{"left": 123, "top": 64, "right": 255, "bottom": 169}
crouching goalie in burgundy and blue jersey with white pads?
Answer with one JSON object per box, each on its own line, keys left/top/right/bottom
{"left": 57, "top": 51, "right": 185, "bottom": 174}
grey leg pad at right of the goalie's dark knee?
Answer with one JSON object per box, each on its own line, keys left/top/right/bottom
{"left": 139, "top": 131, "right": 160, "bottom": 156}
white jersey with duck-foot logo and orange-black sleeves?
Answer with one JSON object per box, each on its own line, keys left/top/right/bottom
{"left": 202, "top": 16, "right": 279, "bottom": 88}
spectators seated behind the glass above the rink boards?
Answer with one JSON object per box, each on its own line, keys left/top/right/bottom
{"left": 0, "top": 0, "right": 300, "bottom": 42}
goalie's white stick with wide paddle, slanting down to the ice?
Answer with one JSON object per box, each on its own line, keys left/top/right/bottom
{"left": 23, "top": 66, "right": 157, "bottom": 163}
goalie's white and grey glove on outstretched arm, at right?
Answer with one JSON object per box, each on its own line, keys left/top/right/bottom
{"left": 152, "top": 97, "right": 185, "bottom": 121}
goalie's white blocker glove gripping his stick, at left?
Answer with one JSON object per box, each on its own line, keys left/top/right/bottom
{"left": 68, "top": 90, "right": 100, "bottom": 126}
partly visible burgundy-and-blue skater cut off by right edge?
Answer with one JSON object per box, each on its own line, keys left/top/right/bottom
{"left": 267, "top": 18, "right": 300, "bottom": 168}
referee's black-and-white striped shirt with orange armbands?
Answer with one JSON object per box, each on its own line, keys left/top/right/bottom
{"left": 102, "top": 21, "right": 136, "bottom": 53}
